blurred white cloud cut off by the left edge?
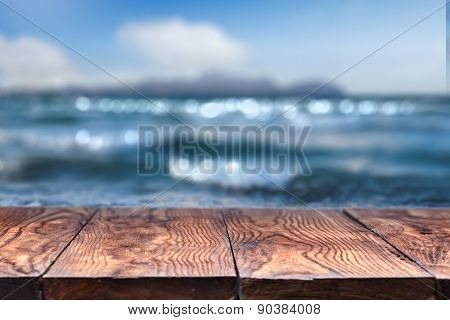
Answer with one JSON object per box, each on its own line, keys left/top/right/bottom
{"left": 0, "top": 35, "right": 79, "bottom": 89}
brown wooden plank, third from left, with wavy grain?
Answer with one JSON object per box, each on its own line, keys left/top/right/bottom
{"left": 225, "top": 209, "right": 434, "bottom": 299}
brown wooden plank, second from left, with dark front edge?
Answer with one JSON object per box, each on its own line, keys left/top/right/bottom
{"left": 44, "top": 208, "right": 237, "bottom": 299}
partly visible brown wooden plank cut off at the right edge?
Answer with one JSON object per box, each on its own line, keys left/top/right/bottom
{"left": 346, "top": 209, "right": 450, "bottom": 298}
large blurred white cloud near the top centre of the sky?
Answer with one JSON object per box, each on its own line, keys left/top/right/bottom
{"left": 118, "top": 19, "right": 246, "bottom": 75}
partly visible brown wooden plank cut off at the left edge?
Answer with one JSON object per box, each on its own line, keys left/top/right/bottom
{"left": 0, "top": 207, "right": 94, "bottom": 299}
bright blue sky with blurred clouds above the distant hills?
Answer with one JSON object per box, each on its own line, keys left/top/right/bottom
{"left": 0, "top": 0, "right": 445, "bottom": 93}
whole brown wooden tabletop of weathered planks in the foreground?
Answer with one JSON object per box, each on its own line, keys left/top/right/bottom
{"left": 0, "top": 208, "right": 450, "bottom": 299}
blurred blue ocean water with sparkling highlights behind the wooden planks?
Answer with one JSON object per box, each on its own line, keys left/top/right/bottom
{"left": 0, "top": 95, "right": 450, "bottom": 207}
